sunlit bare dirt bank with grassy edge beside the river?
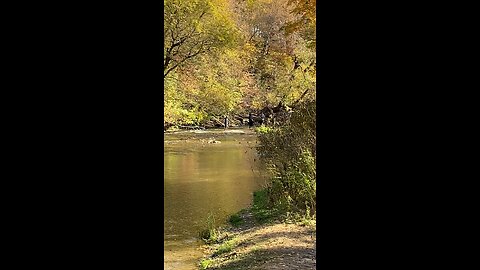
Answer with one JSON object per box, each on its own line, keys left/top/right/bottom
{"left": 201, "top": 211, "right": 316, "bottom": 270}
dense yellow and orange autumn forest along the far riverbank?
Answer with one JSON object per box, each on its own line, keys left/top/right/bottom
{"left": 163, "top": 0, "right": 316, "bottom": 129}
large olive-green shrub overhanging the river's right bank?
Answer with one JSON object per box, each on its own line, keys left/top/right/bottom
{"left": 257, "top": 101, "right": 316, "bottom": 215}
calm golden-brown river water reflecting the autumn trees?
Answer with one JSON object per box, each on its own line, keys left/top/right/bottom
{"left": 163, "top": 129, "right": 265, "bottom": 270}
